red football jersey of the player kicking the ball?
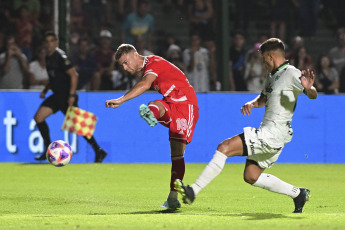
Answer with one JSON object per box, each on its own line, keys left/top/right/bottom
{"left": 143, "top": 55, "right": 198, "bottom": 106}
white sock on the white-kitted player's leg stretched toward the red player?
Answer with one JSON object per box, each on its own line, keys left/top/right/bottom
{"left": 191, "top": 150, "right": 228, "bottom": 195}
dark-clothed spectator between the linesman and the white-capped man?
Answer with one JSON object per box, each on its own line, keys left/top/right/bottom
{"left": 71, "top": 38, "right": 97, "bottom": 90}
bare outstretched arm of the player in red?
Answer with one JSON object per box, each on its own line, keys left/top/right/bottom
{"left": 105, "top": 74, "right": 156, "bottom": 109}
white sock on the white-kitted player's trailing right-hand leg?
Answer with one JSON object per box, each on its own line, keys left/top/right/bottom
{"left": 253, "top": 173, "right": 300, "bottom": 198}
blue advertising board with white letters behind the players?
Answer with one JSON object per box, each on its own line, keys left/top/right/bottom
{"left": 0, "top": 91, "right": 345, "bottom": 163}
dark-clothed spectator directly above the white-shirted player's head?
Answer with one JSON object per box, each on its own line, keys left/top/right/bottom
{"left": 269, "top": 0, "right": 289, "bottom": 40}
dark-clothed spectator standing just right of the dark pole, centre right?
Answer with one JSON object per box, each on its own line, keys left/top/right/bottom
{"left": 229, "top": 31, "right": 247, "bottom": 91}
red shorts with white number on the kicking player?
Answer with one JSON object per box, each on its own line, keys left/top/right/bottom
{"left": 157, "top": 100, "right": 199, "bottom": 144}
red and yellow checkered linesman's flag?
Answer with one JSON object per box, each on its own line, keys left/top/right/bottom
{"left": 61, "top": 106, "right": 97, "bottom": 139}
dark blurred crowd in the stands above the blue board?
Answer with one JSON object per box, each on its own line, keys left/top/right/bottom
{"left": 0, "top": 0, "right": 345, "bottom": 94}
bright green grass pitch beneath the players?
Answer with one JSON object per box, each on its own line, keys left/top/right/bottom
{"left": 0, "top": 163, "right": 345, "bottom": 230}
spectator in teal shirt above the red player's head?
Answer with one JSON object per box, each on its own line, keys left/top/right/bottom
{"left": 121, "top": 0, "right": 154, "bottom": 50}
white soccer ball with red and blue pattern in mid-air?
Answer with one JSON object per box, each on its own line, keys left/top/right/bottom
{"left": 46, "top": 140, "right": 72, "bottom": 167}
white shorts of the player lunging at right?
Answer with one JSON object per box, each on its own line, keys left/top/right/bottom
{"left": 243, "top": 127, "right": 285, "bottom": 168}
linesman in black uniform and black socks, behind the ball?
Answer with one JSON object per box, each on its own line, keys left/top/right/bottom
{"left": 34, "top": 32, "right": 107, "bottom": 162}
